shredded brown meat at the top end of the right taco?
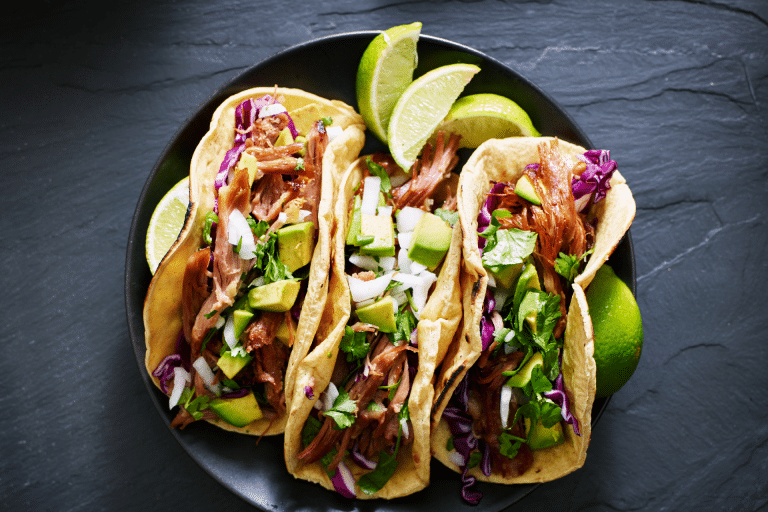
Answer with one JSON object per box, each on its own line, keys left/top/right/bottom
{"left": 499, "top": 140, "right": 594, "bottom": 338}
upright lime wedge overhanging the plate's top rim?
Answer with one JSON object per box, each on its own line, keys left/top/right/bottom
{"left": 355, "top": 22, "right": 421, "bottom": 144}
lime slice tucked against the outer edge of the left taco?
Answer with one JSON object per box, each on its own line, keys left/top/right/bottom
{"left": 145, "top": 177, "right": 189, "bottom": 274}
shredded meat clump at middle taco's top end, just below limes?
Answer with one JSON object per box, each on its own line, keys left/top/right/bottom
{"left": 392, "top": 132, "right": 461, "bottom": 209}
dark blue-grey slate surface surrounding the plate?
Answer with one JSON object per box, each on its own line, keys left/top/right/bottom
{"left": 0, "top": 0, "right": 768, "bottom": 511}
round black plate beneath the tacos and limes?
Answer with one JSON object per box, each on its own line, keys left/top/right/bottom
{"left": 125, "top": 31, "right": 636, "bottom": 512}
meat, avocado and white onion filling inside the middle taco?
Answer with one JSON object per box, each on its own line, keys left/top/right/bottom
{"left": 297, "top": 134, "right": 459, "bottom": 497}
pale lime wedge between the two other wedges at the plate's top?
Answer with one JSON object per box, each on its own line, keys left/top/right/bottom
{"left": 387, "top": 64, "right": 480, "bottom": 171}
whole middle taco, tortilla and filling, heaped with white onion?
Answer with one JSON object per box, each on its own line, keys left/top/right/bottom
{"left": 285, "top": 135, "right": 461, "bottom": 498}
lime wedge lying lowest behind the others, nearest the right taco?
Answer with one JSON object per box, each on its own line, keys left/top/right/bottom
{"left": 433, "top": 94, "right": 541, "bottom": 148}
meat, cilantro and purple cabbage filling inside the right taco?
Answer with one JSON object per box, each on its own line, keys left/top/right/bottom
{"left": 442, "top": 143, "right": 616, "bottom": 503}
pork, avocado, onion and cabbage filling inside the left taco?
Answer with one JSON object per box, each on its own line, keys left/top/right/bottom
{"left": 153, "top": 95, "right": 342, "bottom": 428}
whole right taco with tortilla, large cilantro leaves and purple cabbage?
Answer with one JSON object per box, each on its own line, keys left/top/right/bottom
{"left": 432, "top": 137, "right": 635, "bottom": 503}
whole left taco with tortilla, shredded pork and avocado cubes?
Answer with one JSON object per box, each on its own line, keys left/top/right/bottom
{"left": 144, "top": 87, "right": 364, "bottom": 435}
